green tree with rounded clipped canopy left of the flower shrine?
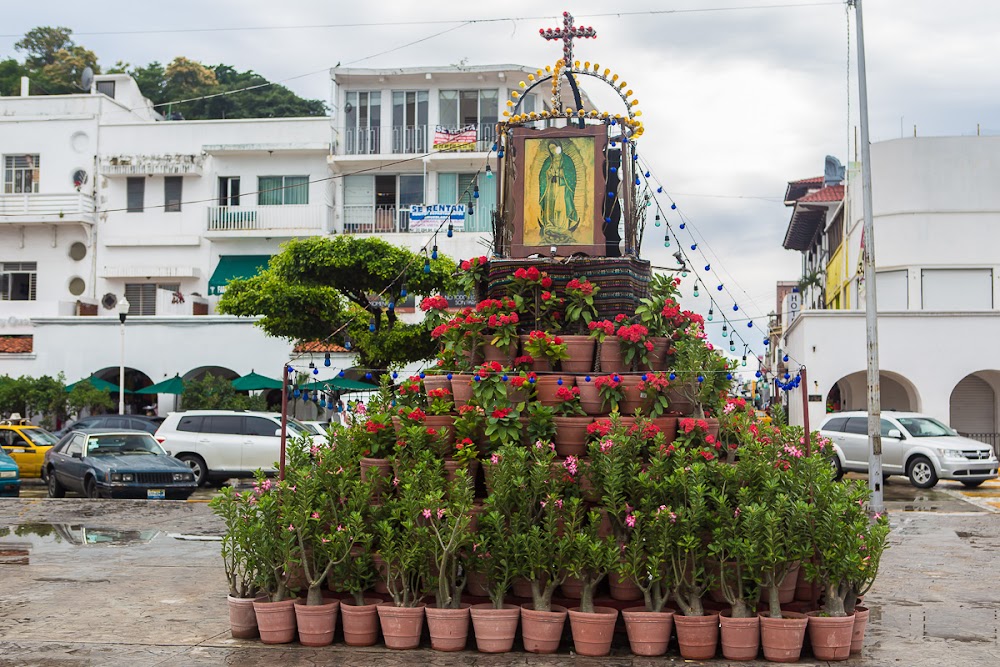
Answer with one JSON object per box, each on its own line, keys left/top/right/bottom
{"left": 219, "top": 236, "right": 454, "bottom": 369}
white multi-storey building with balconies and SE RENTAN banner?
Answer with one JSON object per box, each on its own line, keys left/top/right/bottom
{"left": 0, "top": 65, "right": 580, "bottom": 412}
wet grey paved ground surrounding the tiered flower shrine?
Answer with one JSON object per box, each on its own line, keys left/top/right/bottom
{"left": 0, "top": 483, "right": 1000, "bottom": 667}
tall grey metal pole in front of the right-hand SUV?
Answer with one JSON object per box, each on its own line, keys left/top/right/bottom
{"left": 853, "top": 0, "right": 885, "bottom": 512}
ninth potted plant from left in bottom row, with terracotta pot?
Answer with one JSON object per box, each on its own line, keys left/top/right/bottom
{"left": 564, "top": 498, "right": 619, "bottom": 656}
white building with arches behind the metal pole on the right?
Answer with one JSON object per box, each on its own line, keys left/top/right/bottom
{"left": 783, "top": 137, "right": 1000, "bottom": 443}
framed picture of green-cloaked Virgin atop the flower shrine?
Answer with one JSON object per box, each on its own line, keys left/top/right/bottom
{"left": 509, "top": 125, "right": 607, "bottom": 258}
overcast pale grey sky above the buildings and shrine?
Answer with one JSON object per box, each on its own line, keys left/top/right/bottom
{"left": 0, "top": 0, "right": 1000, "bottom": 360}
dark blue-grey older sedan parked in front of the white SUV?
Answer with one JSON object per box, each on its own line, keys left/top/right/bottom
{"left": 44, "top": 430, "right": 198, "bottom": 500}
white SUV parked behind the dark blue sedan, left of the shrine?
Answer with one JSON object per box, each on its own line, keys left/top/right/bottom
{"left": 155, "top": 410, "right": 326, "bottom": 485}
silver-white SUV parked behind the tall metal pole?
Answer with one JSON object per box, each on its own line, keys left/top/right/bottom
{"left": 819, "top": 411, "right": 1000, "bottom": 489}
